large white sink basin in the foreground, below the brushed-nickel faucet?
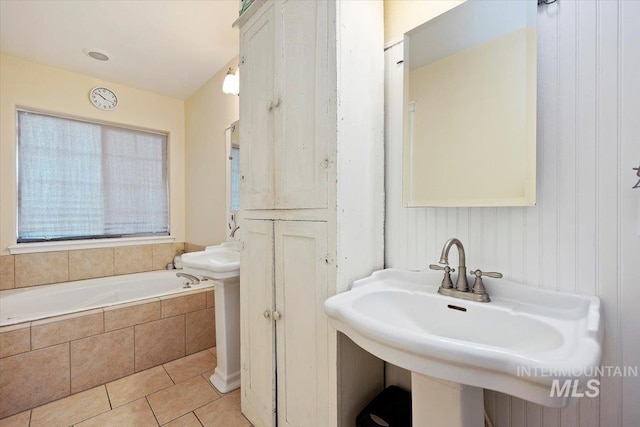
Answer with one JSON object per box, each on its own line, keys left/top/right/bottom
{"left": 325, "top": 269, "right": 603, "bottom": 407}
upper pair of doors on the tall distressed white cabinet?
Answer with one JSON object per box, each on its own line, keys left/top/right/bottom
{"left": 240, "top": 1, "right": 330, "bottom": 209}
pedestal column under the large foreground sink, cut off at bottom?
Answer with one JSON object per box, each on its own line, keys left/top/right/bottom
{"left": 411, "top": 372, "right": 484, "bottom": 427}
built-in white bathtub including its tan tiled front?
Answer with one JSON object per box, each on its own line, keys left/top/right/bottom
{"left": 0, "top": 270, "right": 216, "bottom": 418}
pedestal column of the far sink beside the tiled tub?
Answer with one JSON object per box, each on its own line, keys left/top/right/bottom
{"left": 209, "top": 277, "right": 240, "bottom": 393}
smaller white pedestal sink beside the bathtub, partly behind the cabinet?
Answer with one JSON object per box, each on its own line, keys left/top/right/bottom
{"left": 182, "top": 242, "right": 240, "bottom": 393}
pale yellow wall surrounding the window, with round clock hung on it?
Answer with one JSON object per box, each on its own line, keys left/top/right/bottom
{"left": 0, "top": 55, "right": 188, "bottom": 254}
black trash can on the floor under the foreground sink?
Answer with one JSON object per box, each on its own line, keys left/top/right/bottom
{"left": 356, "top": 385, "right": 411, "bottom": 427}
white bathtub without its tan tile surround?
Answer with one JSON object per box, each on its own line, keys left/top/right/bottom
{"left": 0, "top": 270, "right": 213, "bottom": 327}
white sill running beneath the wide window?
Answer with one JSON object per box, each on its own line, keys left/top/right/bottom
{"left": 9, "top": 236, "right": 175, "bottom": 255}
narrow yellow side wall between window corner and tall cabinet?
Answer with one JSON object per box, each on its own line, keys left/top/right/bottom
{"left": 185, "top": 57, "right": 240, "bottom": 246}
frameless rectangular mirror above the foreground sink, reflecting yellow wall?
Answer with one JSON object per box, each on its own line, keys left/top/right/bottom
{"left": 403, "top": 0, "right": 537, "bottom": 207}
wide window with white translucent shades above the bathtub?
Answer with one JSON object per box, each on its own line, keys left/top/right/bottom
{"left": 18, "top": 110, "right": 169, "bottom": 243}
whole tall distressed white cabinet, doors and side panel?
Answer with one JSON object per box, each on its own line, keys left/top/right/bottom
{"left": 237, "top": 0, "right": 384, "bottom": 427}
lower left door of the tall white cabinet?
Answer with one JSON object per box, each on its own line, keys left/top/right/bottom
{"left": 240, "top": 219, "right": 276, "bottom": 427}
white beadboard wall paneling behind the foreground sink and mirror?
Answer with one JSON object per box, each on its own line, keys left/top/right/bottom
{"left": 385, "top": 0, "right": 640, "bottom": 427}
